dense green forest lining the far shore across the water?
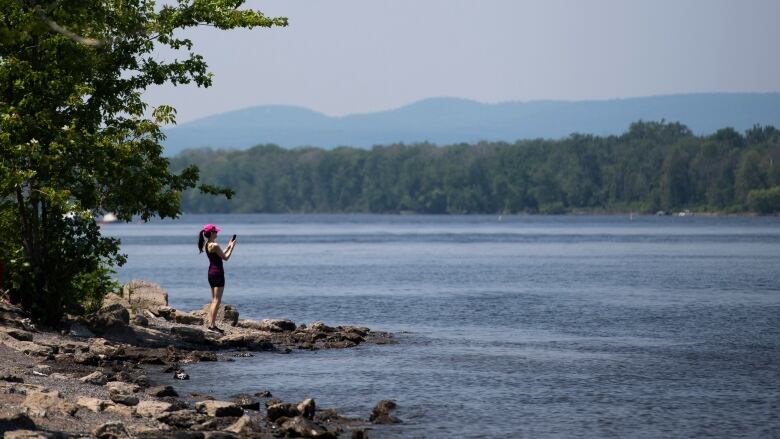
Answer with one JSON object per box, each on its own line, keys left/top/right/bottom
{"left": 171, "top": 121, "right": 780, "bottom": 214}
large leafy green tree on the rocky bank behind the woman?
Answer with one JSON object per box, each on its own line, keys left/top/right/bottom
{"left": 0, "top": 0, "right": 287, "bottom": 323}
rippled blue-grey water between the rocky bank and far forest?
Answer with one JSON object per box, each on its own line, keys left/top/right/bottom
{"left": 105, "top": 215, "right": 780, "bottom": 438}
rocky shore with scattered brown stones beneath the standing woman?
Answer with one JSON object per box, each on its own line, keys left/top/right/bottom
{"left": 0, "top": 281, "right": 400, "bottom": 439}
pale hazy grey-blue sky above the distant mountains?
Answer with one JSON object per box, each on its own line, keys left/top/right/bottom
{"left": 146, "top": 0, "right": 780, "bottom": 123}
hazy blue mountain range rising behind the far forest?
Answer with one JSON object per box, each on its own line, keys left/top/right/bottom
{"left": 163, "top": 93, "right": 780, "bottom": 156}
